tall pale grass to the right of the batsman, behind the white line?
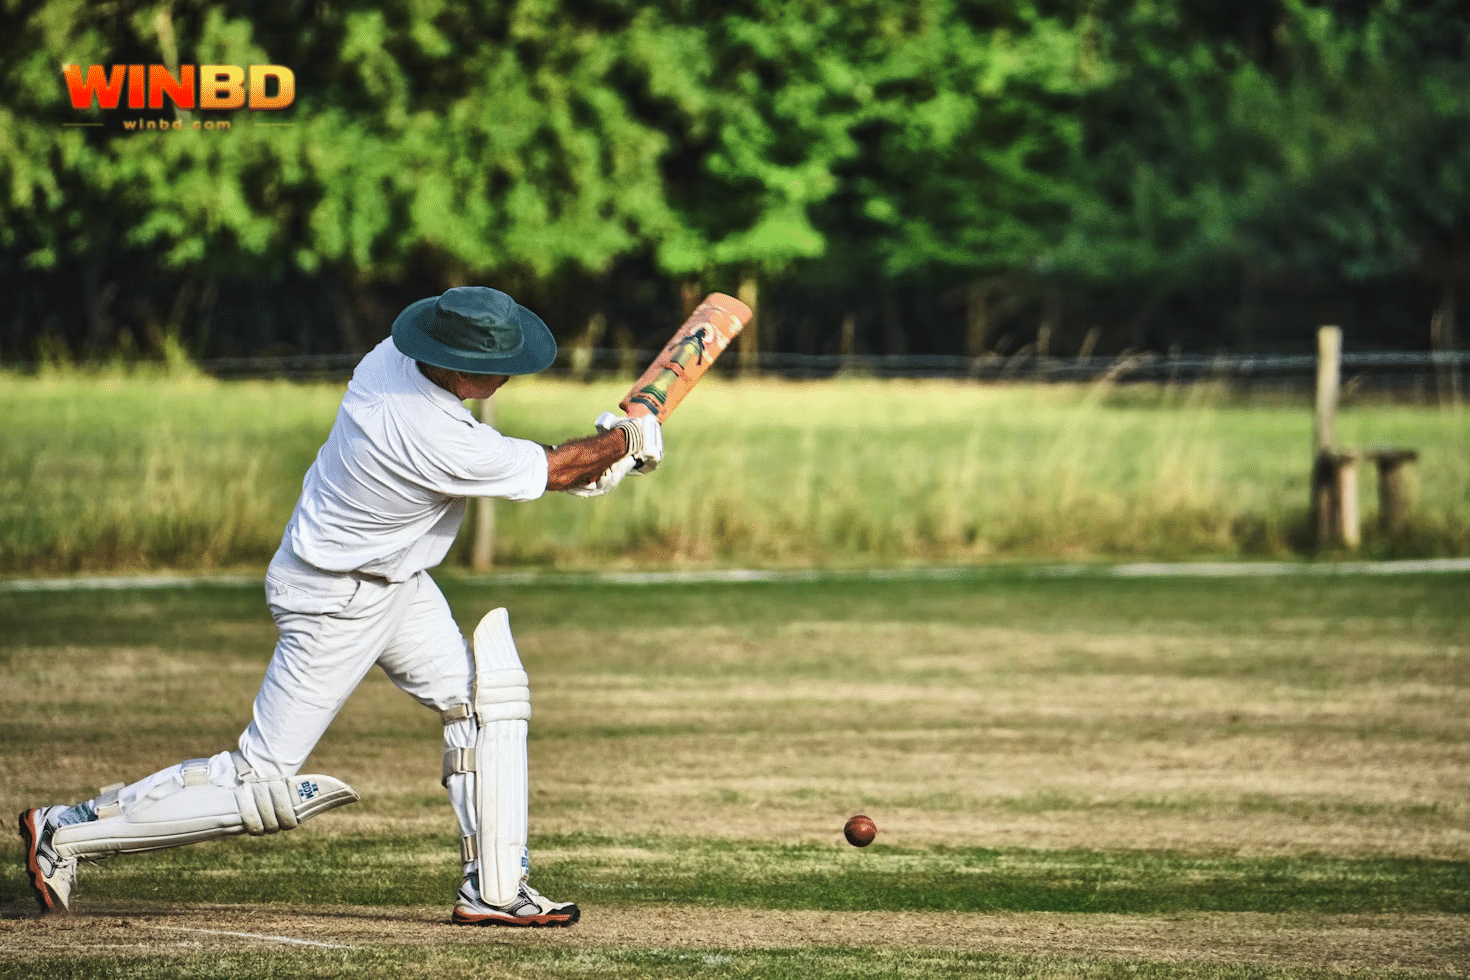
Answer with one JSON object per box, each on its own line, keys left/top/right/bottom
{"left": 497, "top": 371, "right": 1470, "bottom": 564}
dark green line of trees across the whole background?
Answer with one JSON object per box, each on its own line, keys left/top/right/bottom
{"left": 0, "top": 0, "right": 1470, "bottom": 363}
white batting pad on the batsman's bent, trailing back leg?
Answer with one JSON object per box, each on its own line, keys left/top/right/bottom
{"left": 51, "top": 758, "right": 357, "bottom": 858}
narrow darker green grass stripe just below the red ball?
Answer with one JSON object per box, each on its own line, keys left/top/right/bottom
{"left": 17, "top": 835, "right": 1470, "bottom": 914}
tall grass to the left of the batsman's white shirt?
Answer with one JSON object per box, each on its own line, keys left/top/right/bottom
{"left": 0, "top": 370, "right": 341, "bottom": 573}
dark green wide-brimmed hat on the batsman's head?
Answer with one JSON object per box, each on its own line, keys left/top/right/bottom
{"left": 392, "top": 287, "right": 556, "bottom": 375}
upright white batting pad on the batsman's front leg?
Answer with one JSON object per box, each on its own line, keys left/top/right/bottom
{"left": 466, "top": 608, "right": 531, "bottom": 905}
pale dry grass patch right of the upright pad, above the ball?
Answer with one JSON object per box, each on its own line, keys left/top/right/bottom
{"left": 508, "top": 621, "right": 1470, "bottom": 860}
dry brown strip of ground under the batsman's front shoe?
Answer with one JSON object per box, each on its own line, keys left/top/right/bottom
{"left": 0, "top": 902, "right": 1470, "bottom": 977}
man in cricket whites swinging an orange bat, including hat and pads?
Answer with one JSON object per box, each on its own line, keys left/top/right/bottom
{"left": 19, "top": 287, "right": 750, "bottom": 926}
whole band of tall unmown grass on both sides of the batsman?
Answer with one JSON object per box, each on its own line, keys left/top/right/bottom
{"left": 0, "top": 372, "right": 1470, "bottom": 576}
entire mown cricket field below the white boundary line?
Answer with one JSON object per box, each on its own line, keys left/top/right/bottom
{"left": 0, "top": 569, "right": 1470, "bottom": 980}
